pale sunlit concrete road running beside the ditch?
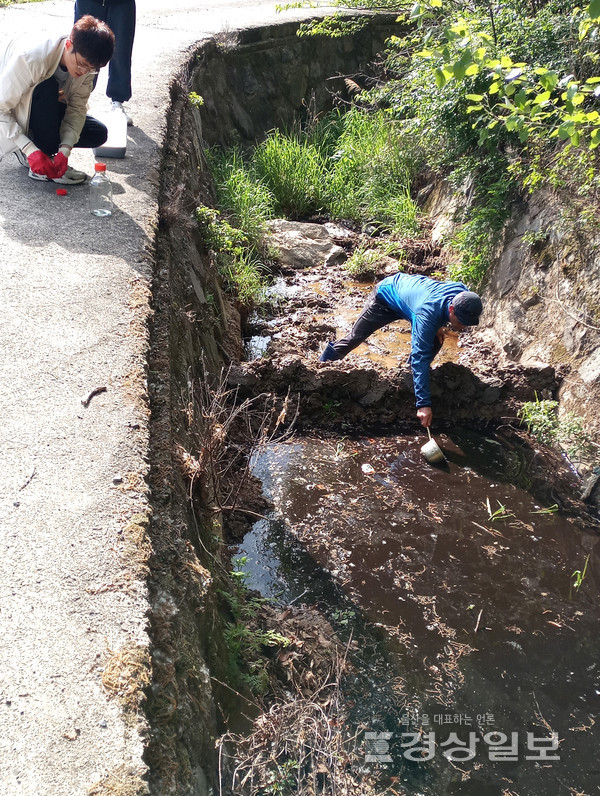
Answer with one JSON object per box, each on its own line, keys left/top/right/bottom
{"left": 0, "top": 0, "right": 328, "bottom": 796}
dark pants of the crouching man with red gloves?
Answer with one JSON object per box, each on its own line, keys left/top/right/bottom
{"left": 27, "top": 77, "right": 108, "bottom": 157}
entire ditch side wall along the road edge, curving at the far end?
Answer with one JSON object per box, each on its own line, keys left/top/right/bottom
{"left": 146, "top": 16, "right": 395, "bottom": 796}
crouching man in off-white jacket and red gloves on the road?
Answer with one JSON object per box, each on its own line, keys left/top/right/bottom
{"left": 0, "top": 15, "right": 115, "bottom": 185}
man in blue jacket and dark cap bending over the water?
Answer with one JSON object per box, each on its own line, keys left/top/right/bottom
{"left": 320, "top": 274, "right": 483, "bottom": 428}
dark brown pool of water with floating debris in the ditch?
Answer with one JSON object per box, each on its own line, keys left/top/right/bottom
{"left": 239, "top": 429, "right": 600, "bottom": 796}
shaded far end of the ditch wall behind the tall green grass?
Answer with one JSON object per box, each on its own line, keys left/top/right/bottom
{"left": 190, "top": 14, "right": 398, "bottom": 151}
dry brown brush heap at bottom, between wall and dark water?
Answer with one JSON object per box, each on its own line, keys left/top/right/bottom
{"left": 218, "top": 592, "right": 380, "bottom": 796}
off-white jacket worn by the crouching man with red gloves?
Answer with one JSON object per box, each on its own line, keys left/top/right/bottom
{"left": 0, "top": 36, "right": 94, "bottom": 155}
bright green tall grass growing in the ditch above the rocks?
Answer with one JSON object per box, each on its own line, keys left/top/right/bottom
{"left": 210, "top": 108, "right": 419, "bottom": 235}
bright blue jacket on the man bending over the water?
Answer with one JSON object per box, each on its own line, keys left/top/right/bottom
{"left": 377, "top": 274, "right": 469, "bottom": 409}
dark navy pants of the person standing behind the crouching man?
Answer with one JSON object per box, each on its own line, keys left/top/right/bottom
{"left": 75, "top": 0, "right": 136, "bottom": 102}
